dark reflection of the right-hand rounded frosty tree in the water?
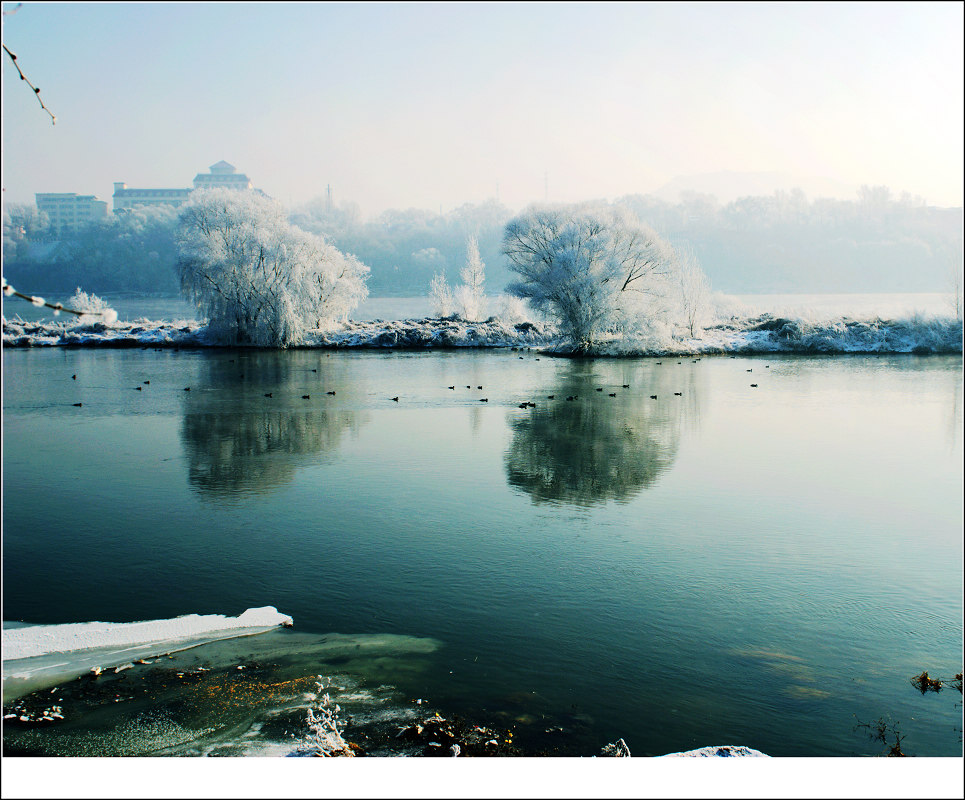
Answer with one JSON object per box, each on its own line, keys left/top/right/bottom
{"left": 505, "top": 361, "right": 698, "bottom": 506}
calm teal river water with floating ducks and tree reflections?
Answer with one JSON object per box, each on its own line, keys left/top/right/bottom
{"left": 3, "top": 350, "right": 962, "bottom": 756}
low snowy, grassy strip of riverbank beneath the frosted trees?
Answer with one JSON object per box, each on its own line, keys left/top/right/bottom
{"left": 3, "top": 314, "right": 962, "bottom": 356}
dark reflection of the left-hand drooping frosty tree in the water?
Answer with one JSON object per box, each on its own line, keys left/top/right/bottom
{"left": 181, "top": 351, "right": 367, "bottom": 499}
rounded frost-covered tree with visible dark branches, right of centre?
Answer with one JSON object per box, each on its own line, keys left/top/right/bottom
{"left": 503, "top": 205, "right": 676, "bottom": 351}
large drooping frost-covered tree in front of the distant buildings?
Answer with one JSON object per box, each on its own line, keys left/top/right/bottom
{"left": 177, "top": 189, "right": 368, "bottom": 347}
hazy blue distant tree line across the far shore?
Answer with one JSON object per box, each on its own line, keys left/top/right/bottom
{"left": 3, "top": 187, "right": 962, "bottom": 296}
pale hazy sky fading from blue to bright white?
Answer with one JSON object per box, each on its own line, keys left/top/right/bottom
{"left": 2, "top": 2, "right": 965, "bottom": 216}
